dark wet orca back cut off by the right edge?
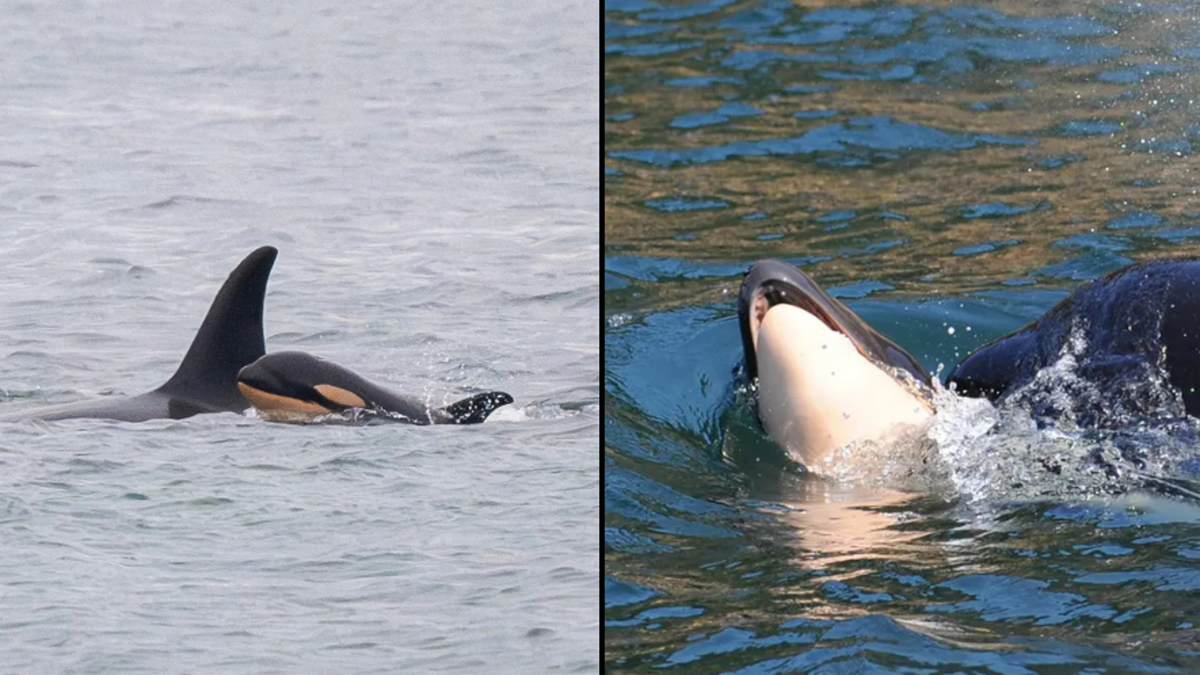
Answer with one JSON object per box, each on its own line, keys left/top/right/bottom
{"left": 948, "top": 258, "right": 1200, "bottom": 426}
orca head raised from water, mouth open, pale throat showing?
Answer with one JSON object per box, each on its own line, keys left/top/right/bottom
{"left": 738, "top": 261, "right": 932, "bottom": 467}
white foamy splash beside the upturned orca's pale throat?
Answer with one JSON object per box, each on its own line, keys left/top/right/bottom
{"left": 792, "top": 348, "right": 1200, "bottom": 506}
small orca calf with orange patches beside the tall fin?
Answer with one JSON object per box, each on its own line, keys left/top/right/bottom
{"left": 238, "top": 352, "right": 512, "bottom": 424}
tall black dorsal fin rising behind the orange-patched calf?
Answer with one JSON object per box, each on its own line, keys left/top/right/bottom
{"left": 157, "top": 246, "right": 278, "bottom": 412}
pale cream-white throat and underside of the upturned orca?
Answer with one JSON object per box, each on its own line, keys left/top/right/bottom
{"left": 756, "top": 304, "right": 932, "bottom": 468}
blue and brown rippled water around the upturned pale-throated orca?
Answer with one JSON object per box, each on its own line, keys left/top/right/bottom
{"left": 604, "top": 0, "right": 1200, "bottom": 674}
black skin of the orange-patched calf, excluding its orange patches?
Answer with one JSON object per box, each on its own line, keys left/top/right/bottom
{"left": 238, "top": 352, "right": 512, "bottom": 424}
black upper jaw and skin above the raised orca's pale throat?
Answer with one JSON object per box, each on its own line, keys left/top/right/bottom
{"left": 738, "top": 261, "right": 931, "bottom": 386}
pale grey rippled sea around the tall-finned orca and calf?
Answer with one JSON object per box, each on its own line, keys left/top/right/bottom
{"left": 0, "top": 1, "right": 600, "bottom": 673}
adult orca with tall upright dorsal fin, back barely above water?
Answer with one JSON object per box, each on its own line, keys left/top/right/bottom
{"left": 0, "top": 246, "right": 278, "bottom": 422}
